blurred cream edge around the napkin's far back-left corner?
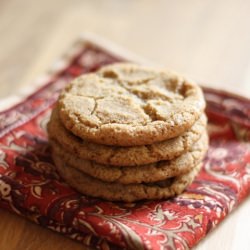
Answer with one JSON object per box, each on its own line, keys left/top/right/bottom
{"left": 0, "top": 32, "right": 156, "bottom": 112}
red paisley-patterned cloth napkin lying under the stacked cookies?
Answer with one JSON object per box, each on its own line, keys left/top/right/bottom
{"left": 0, "top": 36, "right": 250, "bottom": 249}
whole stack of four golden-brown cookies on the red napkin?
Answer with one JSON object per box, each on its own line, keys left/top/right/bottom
{"left": 48, "top": 64, "right": 208, "bottom": 202}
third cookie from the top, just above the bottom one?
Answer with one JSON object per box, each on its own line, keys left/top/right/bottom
{"left": 51, "top": 134, "right": 208, "bottom": 184}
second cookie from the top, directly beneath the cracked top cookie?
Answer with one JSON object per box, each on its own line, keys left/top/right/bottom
{"left": 48, "top": 108, "right": 207, "bottom": 166}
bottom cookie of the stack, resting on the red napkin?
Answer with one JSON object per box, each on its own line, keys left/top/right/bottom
{"left": 52, "top": 154, "right": 201, "bottom": 202}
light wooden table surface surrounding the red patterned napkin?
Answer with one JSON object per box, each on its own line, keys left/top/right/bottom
{"left": 0, "top": 0, "right": 250, "bottom": 250}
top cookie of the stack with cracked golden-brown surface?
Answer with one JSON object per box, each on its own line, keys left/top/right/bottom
{"left": 58, "top": 64, "right": 205, "bottom": 146}
